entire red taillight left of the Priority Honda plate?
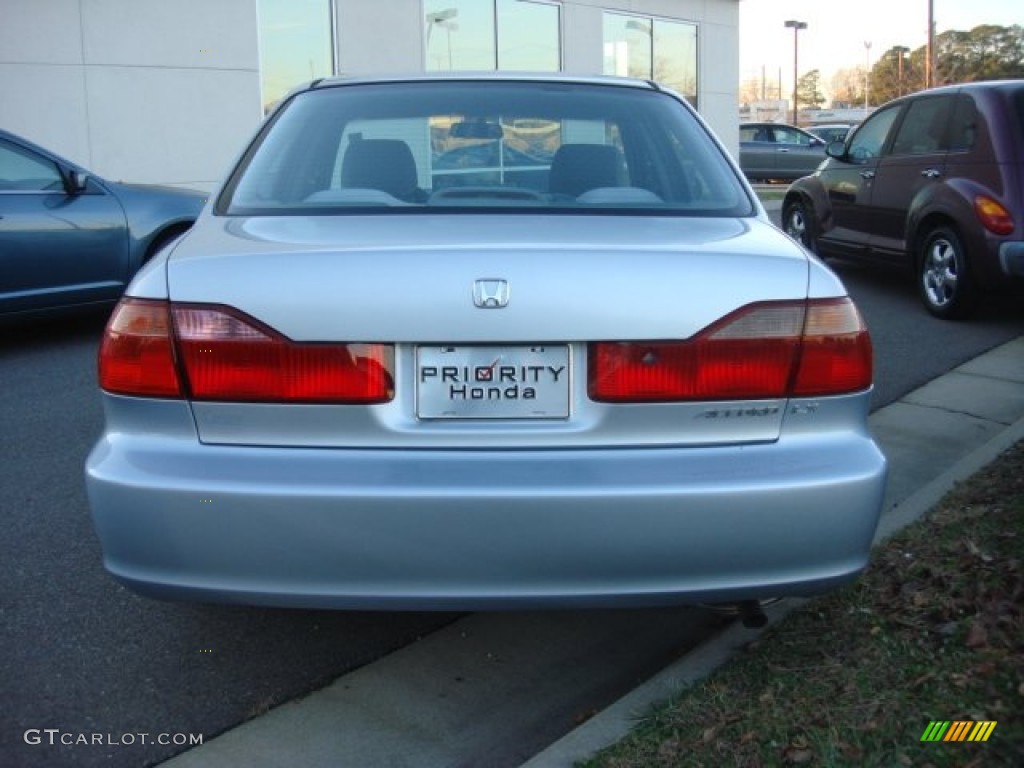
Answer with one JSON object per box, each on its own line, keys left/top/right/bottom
{"left": 100, "top": 299, "right": 394, "bottom": 403}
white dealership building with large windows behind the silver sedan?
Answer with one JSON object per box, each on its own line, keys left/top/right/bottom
{"left": 0, "top": 0, "right": 739, "bottom": 189}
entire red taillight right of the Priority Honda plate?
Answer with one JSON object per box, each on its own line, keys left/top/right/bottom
{"left": 588, "top": 298, "right": 871, "bottom": 402}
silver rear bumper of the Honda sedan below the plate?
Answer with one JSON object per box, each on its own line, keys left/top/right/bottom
{"left": 86, "top": 417, "right": 886, "bottom": 609}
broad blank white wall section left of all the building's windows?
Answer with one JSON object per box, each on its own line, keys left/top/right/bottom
{"left": 0, "top": 0, "right": 262, "bottom": 188}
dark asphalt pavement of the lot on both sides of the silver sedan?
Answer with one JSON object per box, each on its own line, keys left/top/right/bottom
{"left": 0, "top": 264, "right": 1024, "bottom": 766}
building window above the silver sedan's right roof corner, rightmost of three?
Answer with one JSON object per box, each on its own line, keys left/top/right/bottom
{"left": 604, "top": 13, "right": 697, "bottom": 106}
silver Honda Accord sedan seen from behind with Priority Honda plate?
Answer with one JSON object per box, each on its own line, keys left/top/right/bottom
{"left": 86, "top": 75, "right": 886, "bottom": 609}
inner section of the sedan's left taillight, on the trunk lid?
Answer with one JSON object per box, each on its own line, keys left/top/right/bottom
{"left": 172, "top": 305, "right": 394, "bottom": 403}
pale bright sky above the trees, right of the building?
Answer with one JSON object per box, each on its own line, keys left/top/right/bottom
{"left": 739, "top": 0, "right": 1024, "bottom": 92}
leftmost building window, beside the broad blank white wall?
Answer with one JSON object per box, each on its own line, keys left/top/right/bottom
{"left": 259, "top": 0, "right": 334, "bottom": 114}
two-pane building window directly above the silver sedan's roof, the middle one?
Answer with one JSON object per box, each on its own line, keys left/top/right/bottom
{"left": 424, "top": 0, "right": 561, "bottom": 72}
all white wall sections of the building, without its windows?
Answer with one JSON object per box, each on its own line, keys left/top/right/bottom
{"left": 0, "top": 0, "right": 739, "bottom": 188}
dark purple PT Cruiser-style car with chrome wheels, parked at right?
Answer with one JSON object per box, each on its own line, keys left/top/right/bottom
{"left": 782, "top": 80, "right": 1024, "bottom": 319}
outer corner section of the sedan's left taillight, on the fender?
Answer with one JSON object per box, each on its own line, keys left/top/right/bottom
{"left": 99, "top": 299, "right": 181, "bottom": 397}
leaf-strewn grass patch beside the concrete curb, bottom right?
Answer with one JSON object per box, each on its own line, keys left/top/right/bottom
{"left": 585, "top": 442, "right": 1024, "bottom": 768}
